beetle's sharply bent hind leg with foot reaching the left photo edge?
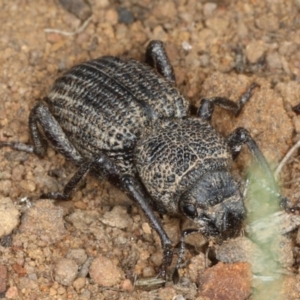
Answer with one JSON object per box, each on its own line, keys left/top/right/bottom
{"left": 0, "top": 102, "right": 83, "bottom": 165}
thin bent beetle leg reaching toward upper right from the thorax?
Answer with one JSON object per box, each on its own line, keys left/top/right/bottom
{"left": 197, "top": 82, "right": 259, "bottom": 121}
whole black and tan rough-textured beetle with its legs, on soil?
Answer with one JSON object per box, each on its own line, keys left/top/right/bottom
{"left": 0, "top": 41, "right": 282, "bottom": 278}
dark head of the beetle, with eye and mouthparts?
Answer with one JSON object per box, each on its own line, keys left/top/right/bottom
{"left": 179, "top": 170, "right": 246, "bottom": 239}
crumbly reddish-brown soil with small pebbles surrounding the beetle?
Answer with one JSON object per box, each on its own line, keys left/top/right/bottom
{"left": 0, "top": 0, "right": 300, "bottom": 300}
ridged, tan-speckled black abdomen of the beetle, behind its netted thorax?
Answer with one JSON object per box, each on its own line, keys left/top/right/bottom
{"left": 48, "top": 56, "right": 189, "bottom": 173}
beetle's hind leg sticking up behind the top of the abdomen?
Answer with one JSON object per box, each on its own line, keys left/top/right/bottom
{"left": 146, "top": 41, "right": 176, "bottom": 85}
